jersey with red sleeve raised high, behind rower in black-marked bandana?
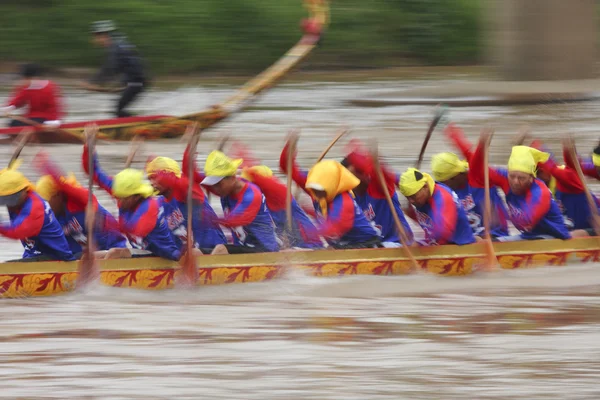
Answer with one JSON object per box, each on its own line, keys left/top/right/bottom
{"left": 444, "top": 124, "right": 508, "bottom": 237}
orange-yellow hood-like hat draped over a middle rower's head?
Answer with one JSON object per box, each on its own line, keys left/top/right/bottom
{"left": 306, "top": 160, "right": 360, "bottom": 216}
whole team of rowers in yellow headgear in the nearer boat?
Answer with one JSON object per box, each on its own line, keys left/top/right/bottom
{"left": 0, "top": 119, "right": 600, "bottom": 261}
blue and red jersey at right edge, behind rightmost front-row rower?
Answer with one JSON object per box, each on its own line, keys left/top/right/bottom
{"left": 540, "top": 151, "right": 598, "bottom": 229}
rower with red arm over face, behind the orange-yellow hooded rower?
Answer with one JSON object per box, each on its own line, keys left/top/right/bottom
{"left": 342, "top": 141, "right": 414, "bottom": 247}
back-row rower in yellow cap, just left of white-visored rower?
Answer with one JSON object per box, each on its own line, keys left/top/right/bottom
{"left": 146, "top": 157, "right": 227, "bottom": 253}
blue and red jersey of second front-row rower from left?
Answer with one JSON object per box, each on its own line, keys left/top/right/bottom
{"left": 83, "top": 146, "right": 181, "bottom": 260}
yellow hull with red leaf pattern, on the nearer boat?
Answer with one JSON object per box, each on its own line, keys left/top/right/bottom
{"left": 0, "top": 238, "right": 600, "bottom": 298}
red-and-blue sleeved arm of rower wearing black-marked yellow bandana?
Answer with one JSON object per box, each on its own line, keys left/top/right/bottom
{"left": 431, "top": 190, "right": 458, "bottom": 244}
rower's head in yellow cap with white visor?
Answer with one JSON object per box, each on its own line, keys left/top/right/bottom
{"left": 201, "top": 150, "right": 244, "bottom": 197}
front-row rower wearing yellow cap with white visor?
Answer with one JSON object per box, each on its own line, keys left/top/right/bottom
{"left": 201, "top": 150, "right": 279, "bottom": 254}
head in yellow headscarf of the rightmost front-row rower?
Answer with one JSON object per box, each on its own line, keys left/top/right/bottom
{"left": 508, "top": 146, "right": 550, "bottom": 196}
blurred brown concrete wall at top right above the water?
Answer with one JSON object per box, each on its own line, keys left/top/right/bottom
{"left": 490, "top": 0, "right": 597, "bottom": 80}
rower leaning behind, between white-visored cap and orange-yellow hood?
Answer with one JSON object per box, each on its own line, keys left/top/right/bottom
{"left": 242, "top": 165, "right": 323, "bottom": 249}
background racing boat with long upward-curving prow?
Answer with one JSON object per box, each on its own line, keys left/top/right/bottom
{"left": 0, "top": 0, "right": 329, "bottom": 143}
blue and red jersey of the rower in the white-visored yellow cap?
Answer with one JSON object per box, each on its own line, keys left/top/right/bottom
{"left": 218, "top": 181, "right": 279, "bottom": 252}
